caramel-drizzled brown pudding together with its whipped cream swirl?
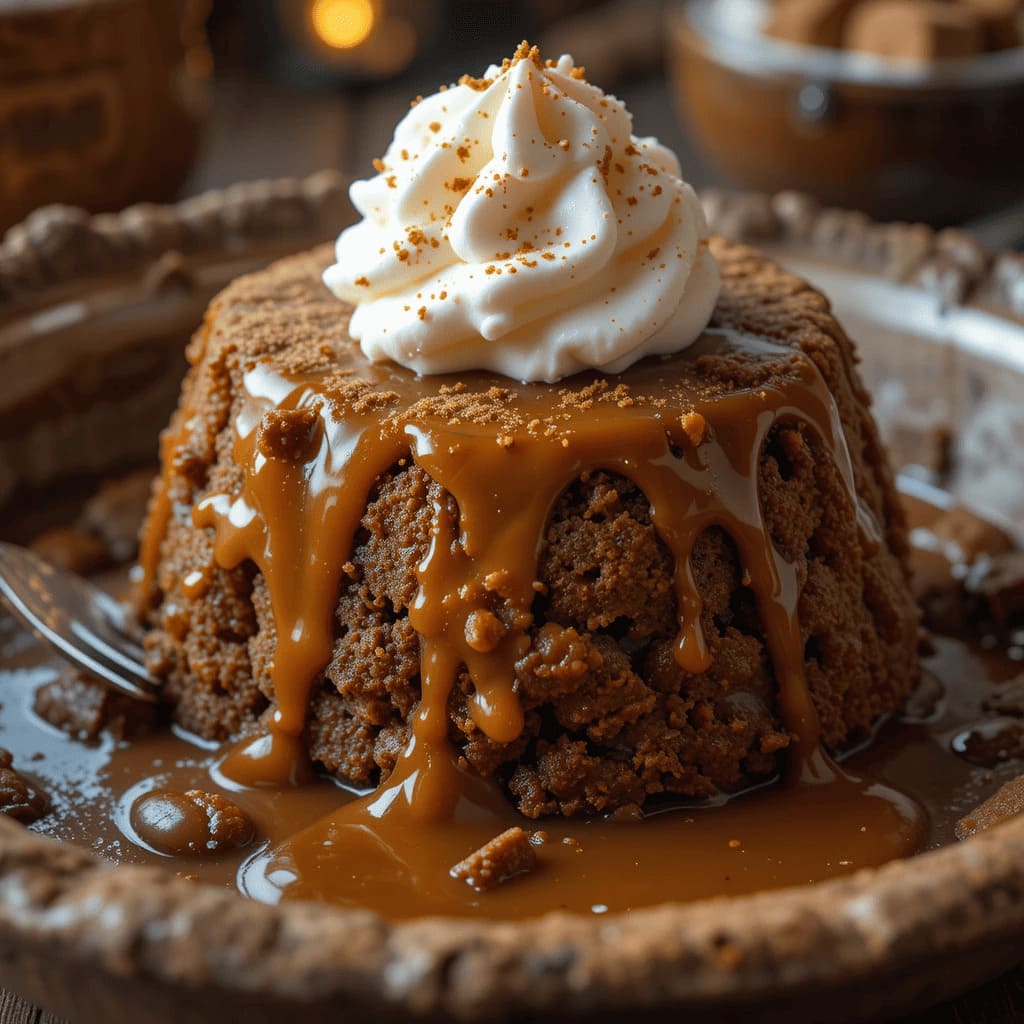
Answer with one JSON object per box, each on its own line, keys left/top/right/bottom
{"left": 137, "top": 46, "right": 918, "bottom": 817}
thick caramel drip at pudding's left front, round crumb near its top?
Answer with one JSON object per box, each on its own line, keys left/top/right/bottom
{"left": 193, "top": 368, "right": 408, "bottom": 785}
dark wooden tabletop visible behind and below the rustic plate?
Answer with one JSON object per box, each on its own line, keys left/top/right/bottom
{"left": 8, "top": 64, "right": 1024, "bottom": 1024}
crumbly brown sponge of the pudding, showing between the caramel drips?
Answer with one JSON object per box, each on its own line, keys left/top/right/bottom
{"left": 139, "top": 241, "right": 919, "bottom": 817}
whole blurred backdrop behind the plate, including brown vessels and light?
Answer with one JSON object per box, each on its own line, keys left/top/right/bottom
{"left": 0, "top": 0, "right": 1024, "bottom": 248}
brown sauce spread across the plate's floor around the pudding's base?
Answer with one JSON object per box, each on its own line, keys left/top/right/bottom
{"left": 0, "top": 507, "right": 1024, "bottom": 920}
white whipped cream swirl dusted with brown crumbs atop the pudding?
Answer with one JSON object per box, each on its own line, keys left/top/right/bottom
{"left": 324, "top": 45, "right": 719, "bottom": 381}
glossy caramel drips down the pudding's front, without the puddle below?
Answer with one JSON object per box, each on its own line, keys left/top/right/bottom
{"left": 182, "top": 332, "right": 864, "bottom": 806}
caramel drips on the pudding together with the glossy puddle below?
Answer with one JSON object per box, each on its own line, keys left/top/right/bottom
{"left": 125, "top": 323, "right": 942, "bottom": 916}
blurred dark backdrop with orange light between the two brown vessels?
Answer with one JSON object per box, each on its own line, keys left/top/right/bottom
{"left": 188, "top": 0, "right": 711, "bottom": 199}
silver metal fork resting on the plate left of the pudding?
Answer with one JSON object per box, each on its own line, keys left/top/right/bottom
{"left": 0, "top": 543, "right": 159, "bottom": 703}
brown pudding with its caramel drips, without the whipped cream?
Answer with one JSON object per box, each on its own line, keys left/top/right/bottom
{"left": 134, "top": 235, "right": 918, "bottom": 817}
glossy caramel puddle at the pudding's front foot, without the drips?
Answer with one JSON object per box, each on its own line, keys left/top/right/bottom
{"left": 238, "top": 769, "right": 926, "bottom": 919}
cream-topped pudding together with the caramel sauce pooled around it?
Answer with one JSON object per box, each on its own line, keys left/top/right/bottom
{"left": 0, "top": 46, "right": 1024, "bottom": 937}
